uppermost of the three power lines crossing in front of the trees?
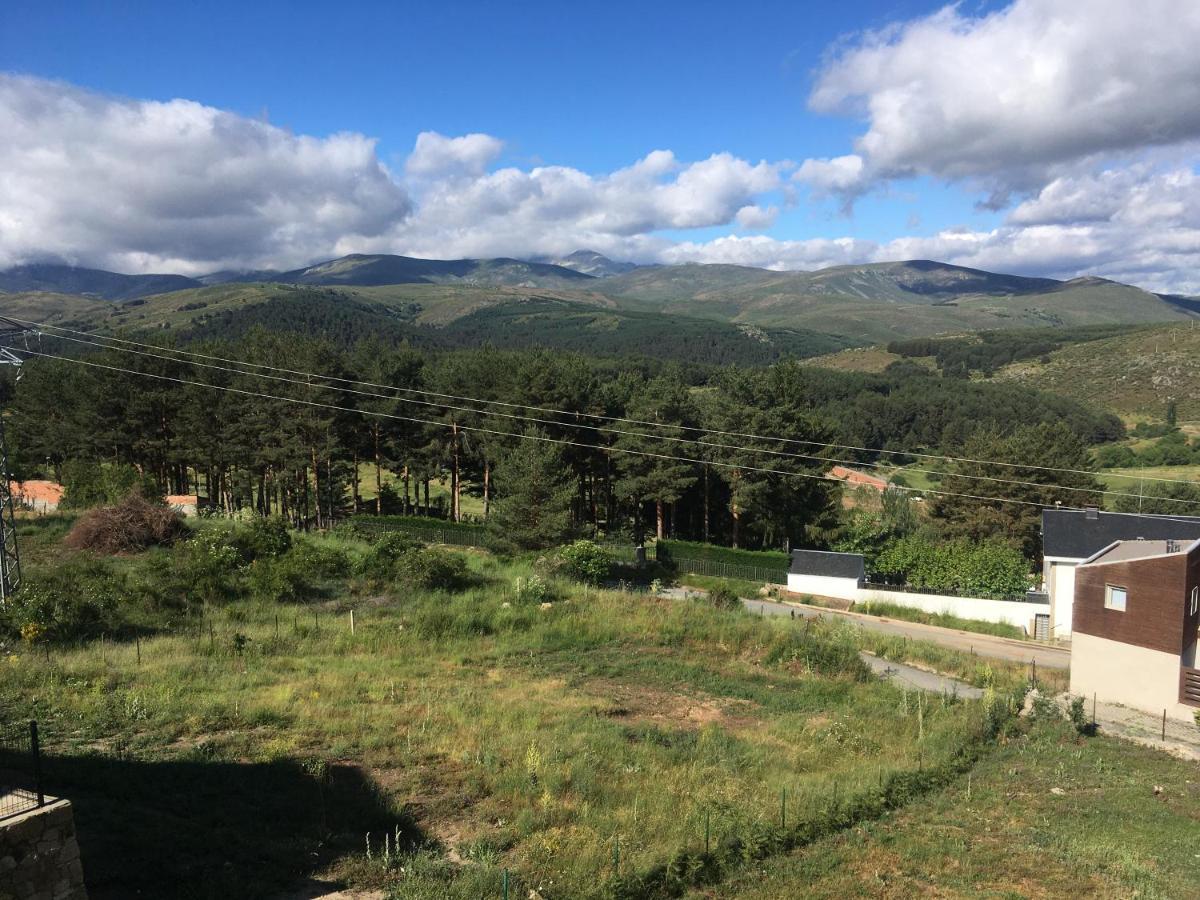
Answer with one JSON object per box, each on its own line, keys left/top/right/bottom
{"left": 13, "top": 319, "right": 1195, "bottom": 496}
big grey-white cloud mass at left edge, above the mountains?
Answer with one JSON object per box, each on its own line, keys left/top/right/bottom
{"left": 0, "top": 74, "right": 412, "bottom": 272}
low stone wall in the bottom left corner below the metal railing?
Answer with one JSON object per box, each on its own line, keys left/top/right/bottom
{"left": 0, "top": 799, "right": 88, "bottom": 900}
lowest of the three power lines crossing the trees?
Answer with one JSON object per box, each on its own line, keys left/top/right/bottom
{"left": 20, "top": 349, "right": 1132, "bottom": 518}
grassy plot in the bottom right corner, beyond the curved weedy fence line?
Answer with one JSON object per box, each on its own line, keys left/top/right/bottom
{"left": 695, "top": 724, "right": 1200, "bottom": 900}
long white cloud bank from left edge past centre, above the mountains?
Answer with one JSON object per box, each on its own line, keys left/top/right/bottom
{"left": 0, "top": 76, "right": 786, "bottom": 274}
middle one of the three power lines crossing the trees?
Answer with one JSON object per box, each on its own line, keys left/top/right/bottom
{"left": 18, "top": 336, "right": 1200, "bottom": 506}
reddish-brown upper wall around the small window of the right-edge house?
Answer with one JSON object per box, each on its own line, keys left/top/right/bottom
{"left": 1073, "top": 553, "right": 1200, "bottom": 654}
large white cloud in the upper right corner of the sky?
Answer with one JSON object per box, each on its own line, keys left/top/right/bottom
{"left": 800, "top": 0, "right": 1200, "bottom": 196}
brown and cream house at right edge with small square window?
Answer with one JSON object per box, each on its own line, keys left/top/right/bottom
{"left": 1070, "top": 539, "right": 1200, "bottom": 721}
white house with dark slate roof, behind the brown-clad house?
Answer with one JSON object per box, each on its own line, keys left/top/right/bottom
{"left": 1042, "top": 508, "right": 1200, "bottom": 638}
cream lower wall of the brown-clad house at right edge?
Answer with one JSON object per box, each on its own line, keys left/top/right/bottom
{"left": 1070, "top": 634, "right": 1194, "bottom": 721}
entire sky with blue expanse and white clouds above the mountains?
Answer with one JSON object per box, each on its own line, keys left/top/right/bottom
{"left": 0, "top": 0, "right": 1200, "bottom": 293}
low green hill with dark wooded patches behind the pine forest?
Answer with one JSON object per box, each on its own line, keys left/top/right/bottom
{"left": 9, "top": 283, "right": 851, "bottom": 365}
